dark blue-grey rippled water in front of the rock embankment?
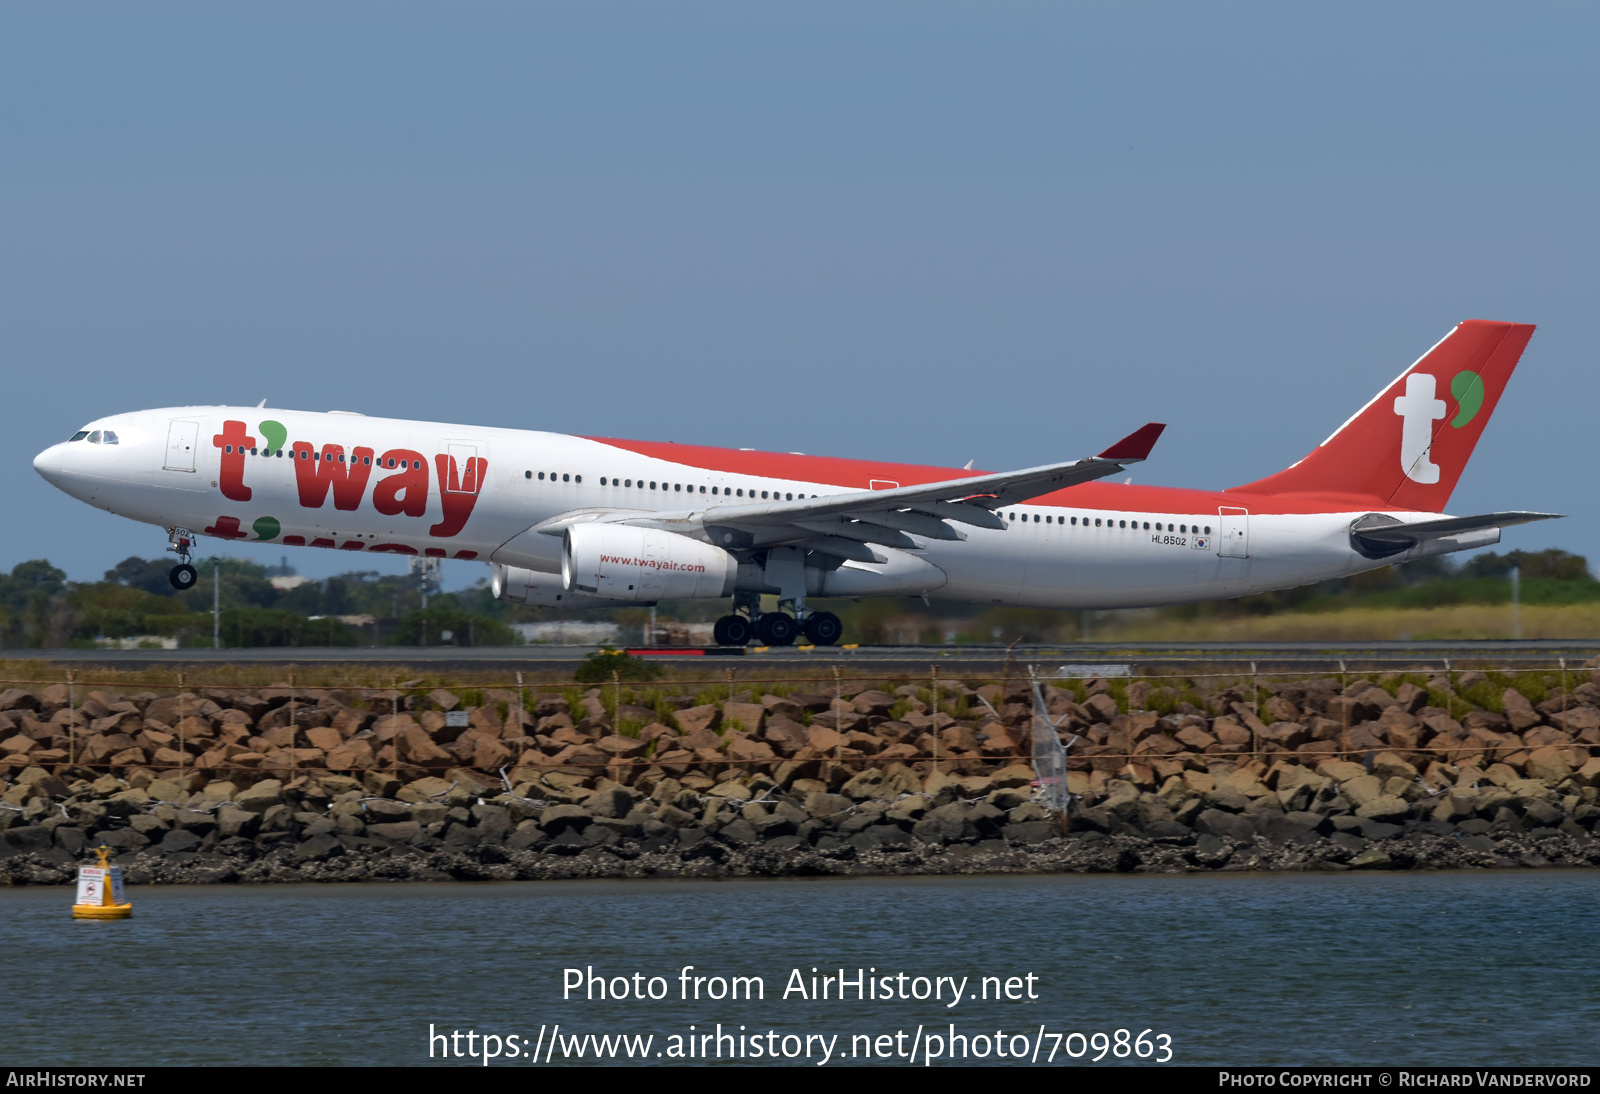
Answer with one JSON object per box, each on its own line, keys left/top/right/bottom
{"left": 0, "top": 872, "right": 1600, "bottom": 1068}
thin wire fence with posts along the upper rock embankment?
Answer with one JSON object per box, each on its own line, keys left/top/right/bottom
{"left": 0, "top": 657, "right": 1600, "bottom": 787}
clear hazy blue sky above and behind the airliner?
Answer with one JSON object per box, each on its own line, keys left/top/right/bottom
{"left": 0, "top": 2, "right": 1600, "bottom": 584}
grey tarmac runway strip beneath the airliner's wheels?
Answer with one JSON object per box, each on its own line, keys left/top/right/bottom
{"left": 0, "top": 640, "right": 1600, "bottom": 677}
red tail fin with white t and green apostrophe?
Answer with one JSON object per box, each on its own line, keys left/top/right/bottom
{"left": 1234, "top": 320, "right": 1533, "bottom": 513}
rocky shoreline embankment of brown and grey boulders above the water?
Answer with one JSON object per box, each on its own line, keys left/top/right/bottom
{"left": 0, "top": 667, "right": 1600, "bottom": 884}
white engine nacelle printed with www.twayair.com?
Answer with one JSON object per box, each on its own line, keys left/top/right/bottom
{"left": 562, "top": 523, "right": 739, "bottom": 601}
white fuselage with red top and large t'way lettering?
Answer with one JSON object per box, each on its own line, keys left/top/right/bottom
{"left": 34, "top": 406, "right": 1465, "bottom": 608}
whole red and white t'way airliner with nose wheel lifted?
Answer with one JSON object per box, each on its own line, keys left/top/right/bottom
{"left": 34, "top": 320, "right": 1557, "bottom": 646}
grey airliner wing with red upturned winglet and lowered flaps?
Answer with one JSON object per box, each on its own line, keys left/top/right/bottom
{"left": 533, "top": 422, "right": 1166, "bottom": 563}
